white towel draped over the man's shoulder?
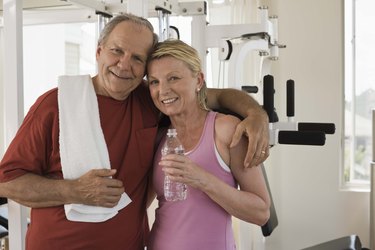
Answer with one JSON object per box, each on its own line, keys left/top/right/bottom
{"left": 58, "top": 75, "right": 131, "bottom": 222}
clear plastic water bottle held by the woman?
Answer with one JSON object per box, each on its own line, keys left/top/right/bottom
{"left": 161, "top": 128, "right": 187, "bottom": 201}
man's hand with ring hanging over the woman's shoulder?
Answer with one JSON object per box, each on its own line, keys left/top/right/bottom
{"left": 230, "top": 111, "right": 269, "bottom": 167}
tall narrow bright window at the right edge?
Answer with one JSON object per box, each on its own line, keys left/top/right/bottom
{"left": 343, "top": 0, "right": 375, "bottom": 189}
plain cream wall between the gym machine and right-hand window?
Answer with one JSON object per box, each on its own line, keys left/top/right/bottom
{"left": 265, "top": 0, "right": 369, "bottom": 250}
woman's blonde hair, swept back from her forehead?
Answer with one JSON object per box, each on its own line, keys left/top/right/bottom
{"left": 148, "top": 39, "right": 209, "bottom": 110}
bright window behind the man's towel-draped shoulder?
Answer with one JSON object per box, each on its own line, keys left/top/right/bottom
{"left": 23, "top": 22, "right": 97, "bottom": 114}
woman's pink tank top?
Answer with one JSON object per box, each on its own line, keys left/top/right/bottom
{"left": 147, "top": 112, "right": 236, "bottom": 250}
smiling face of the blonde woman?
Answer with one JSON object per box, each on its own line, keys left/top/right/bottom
{"left": 147, "top": 56, "right": 203, "bottom": 116}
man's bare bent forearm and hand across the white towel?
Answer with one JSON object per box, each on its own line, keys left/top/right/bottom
{"left": 0, "top": 169, "right": 124, "bottom": 208}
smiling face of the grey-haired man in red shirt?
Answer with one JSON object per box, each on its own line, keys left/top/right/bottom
{"left": 94, "top": 22, "right": 153, "bottom": 100}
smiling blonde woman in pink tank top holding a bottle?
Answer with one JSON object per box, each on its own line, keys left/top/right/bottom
{"left": 147, "top": 40, "right": 270, "bottom": 250}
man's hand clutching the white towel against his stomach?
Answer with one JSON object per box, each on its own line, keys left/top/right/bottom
{"left": 72, "top": 169, "right": 124, "bottom": 207}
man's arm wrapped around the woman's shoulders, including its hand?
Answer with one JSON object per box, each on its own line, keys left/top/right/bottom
{"left": 207, "top": 89, "right": 269, "bottom": 167}
